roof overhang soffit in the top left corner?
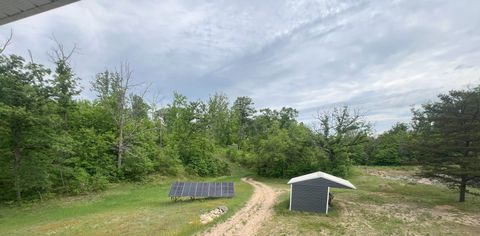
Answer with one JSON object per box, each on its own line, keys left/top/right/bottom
{"left": 0, "top": 0, "right": 79, "bottom": 25}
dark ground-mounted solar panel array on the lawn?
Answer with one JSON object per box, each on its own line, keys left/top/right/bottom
{"left": 168, "top": 182, "right": 234, "bottom": 198}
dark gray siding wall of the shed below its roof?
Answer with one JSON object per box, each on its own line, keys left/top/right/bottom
{"left": 290, "top": 184, "right": 328, "bottom": 213}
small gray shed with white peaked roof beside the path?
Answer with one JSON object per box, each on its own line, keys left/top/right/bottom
{"left": 288, "top": 171, "right": 356, "bottom": 214}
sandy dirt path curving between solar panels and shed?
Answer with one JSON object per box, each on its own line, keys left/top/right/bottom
{"left": 203, "top": 178, "right": 277, "bottom": 236}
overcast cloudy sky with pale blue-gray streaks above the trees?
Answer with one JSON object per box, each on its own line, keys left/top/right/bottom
{"left": 0, "top": 0, "right": 480, "bottom": 132}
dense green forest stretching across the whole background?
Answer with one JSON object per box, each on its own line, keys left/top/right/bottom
{"left": 0, "top": 48, "right": 480, "bottom": 201}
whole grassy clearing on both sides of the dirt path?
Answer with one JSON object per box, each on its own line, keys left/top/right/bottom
{"left": 0, "top": 167, "right": 480, "bottom": 235}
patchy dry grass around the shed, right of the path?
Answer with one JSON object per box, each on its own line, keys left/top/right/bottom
{"left": 259, "top": 167, "right": 480, "bottom": 235}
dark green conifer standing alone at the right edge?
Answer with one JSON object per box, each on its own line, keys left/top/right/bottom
{"left": 413, "top": 87, "right": 480, "bottom": 202}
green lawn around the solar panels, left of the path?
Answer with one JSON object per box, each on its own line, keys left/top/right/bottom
{"left": 0, "top": 166, "right": 253, "bottom": 235}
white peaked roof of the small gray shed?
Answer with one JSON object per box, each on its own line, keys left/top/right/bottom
{"left": 288, "top": 171, "right": 357, "bottom": 189}
